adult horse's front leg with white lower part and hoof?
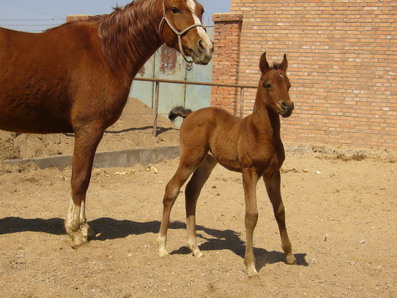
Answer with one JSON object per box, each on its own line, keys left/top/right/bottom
{"left": 65, "top": 125, "right": 104, "bottom": 248}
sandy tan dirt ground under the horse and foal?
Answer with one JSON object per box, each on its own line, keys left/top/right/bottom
{"left": 0, "top": 101, "right": 397, "bottom": 297}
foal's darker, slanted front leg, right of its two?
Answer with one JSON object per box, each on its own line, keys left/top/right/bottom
{"left": 263, "top": 171, "right": 296, "bottom": 265}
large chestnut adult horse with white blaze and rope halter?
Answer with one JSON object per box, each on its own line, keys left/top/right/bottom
{"left": 0, "top": 0, "right": 213, "bottom": 247}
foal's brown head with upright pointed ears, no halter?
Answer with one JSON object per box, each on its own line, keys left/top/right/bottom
{"left": 258, "top": 53, "right": 294, "bottom": 118}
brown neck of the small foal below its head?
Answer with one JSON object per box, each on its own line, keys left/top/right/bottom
{"left": 252, "top": 90, "right": 280, "bottom": 140}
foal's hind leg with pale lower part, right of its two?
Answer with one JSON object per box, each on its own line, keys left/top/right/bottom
{"left": 185, "top": 155, "right": 217, "bottom": 257}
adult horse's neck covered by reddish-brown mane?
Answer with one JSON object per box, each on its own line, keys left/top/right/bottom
{"left": 98, "top": 0, "right": 163, "bottom": 78}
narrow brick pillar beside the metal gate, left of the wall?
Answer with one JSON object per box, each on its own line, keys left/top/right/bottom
{"left": 211, "top": 13, "right": 242, "bottom": 113}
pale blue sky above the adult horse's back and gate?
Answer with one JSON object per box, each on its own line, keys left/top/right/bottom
{"left": 0, "top": 0, "right": 231, "bottom": 32}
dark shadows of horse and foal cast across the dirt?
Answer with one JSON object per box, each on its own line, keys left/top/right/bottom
{"left": 0, "top": 217, "right": 309, "bottom": 270}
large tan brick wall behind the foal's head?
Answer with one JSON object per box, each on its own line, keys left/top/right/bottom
{"left": 214, "top": 0, "right": 397, "bottom": 149}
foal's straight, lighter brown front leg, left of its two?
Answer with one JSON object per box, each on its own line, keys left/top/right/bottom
{"left": 242, "top": 169, "right": 258, "bottom": 277}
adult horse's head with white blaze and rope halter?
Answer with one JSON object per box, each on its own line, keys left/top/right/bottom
{"left": 157, "top": 0, "right": 214, "bottom": 64}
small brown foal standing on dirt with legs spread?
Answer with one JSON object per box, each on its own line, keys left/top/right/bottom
{"left": 158, "top": 53, "right": 296, "bottom": 276}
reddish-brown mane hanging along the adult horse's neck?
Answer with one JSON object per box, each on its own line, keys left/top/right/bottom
{"left": 45, "top": 0, "right": 161, "bottom": 68}
